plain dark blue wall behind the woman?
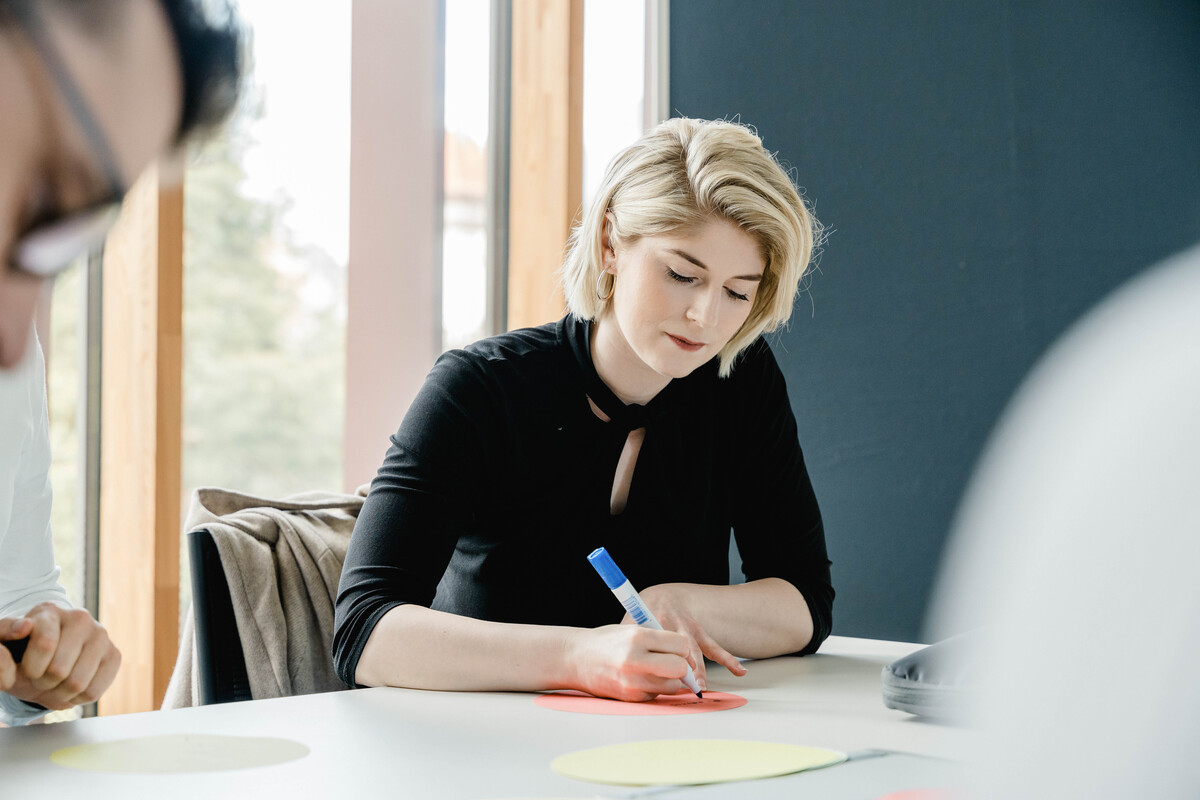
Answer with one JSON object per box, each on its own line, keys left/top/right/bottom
{"left": 671, "top": 0, "right": 1200, "bottom": 640}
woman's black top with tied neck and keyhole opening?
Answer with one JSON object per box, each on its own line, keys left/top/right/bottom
{"left": 334, "top": 317, "right": 834, "bottom": 685}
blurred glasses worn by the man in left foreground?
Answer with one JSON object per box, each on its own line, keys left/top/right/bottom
{"left": 10, "top": 0, "right": 125, "bottom": 278}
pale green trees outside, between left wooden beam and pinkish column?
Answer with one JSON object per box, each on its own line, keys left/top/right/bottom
{"left": 184, "top": 115, "right": 346, "bottom": 501}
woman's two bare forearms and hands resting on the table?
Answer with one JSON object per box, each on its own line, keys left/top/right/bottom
{"left": 355, "top": 578, "right": 812, "bottom": 699}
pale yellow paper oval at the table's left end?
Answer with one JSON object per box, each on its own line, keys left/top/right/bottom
{"left": 50, "top": 733, "right": 308, "bottom": 774}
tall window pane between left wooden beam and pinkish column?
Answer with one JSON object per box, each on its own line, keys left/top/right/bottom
{"left": 180, "top": 0, "right": 350, "bottom": 599}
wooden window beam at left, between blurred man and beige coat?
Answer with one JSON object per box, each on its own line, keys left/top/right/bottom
{"left": 100, "top": 168, "right": 184, "bottom": 714}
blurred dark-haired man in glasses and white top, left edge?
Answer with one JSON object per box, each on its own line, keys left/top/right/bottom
{"left": 0, "top": 0, "right": 239, "bottom": 724}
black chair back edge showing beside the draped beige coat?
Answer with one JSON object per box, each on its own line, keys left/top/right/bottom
{"left": 187, "top": 528, "right": 251, "bottom": 705}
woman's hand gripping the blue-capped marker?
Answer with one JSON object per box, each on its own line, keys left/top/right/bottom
{"left": 568, "top": 625, "right": 696, "bottom": 702}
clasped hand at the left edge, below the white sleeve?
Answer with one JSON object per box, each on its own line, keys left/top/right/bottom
{"left": 0, "top": 603, "right": 121, "bottom": 709}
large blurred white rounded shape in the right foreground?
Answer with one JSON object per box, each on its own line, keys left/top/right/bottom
{"left": 931, "top": 247, "right": 1200, "bottom": 800}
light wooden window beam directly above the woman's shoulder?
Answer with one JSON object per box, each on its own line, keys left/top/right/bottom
{"left": 508, "top": 0, "right": 583, "bottom": 329}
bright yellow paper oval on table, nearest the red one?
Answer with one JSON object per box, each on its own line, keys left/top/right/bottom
{"left": 550, "top": 739, "right": 846, "bottom": 786}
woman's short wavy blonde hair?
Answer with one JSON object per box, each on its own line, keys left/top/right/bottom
{"left": 560, "top": 118, "right": 822, "bottom": 378}
